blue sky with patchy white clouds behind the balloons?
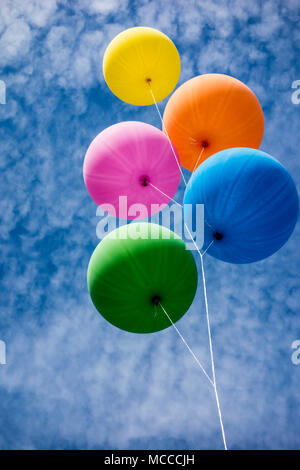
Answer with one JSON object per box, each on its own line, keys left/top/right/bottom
{"left": 0, "top": 0, "right": 300, "bottom": 449}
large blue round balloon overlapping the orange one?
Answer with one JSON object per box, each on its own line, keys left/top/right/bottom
{"left": 184, "top": 148, "right": 298, "bottom": 263}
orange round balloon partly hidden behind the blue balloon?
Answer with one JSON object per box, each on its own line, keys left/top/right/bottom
{"left": 163, "top": 74, "right": 264, "bottom": 171}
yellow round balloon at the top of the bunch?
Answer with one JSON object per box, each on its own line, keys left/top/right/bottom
{"left": 103, "top": 27, "right": 180, "bottom": 106}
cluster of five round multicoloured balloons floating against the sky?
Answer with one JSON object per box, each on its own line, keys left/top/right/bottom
{"left": 83, "top": 27, "right": 298, "bottom": 333}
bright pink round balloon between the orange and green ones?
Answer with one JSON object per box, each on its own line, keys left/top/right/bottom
{"left": 83, "top": 121, "right": 180, "bottom": 219}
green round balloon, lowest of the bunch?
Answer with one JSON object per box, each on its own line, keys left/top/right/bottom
{"left": 87, "top": 223, "right": 197, "bottom": 333}
